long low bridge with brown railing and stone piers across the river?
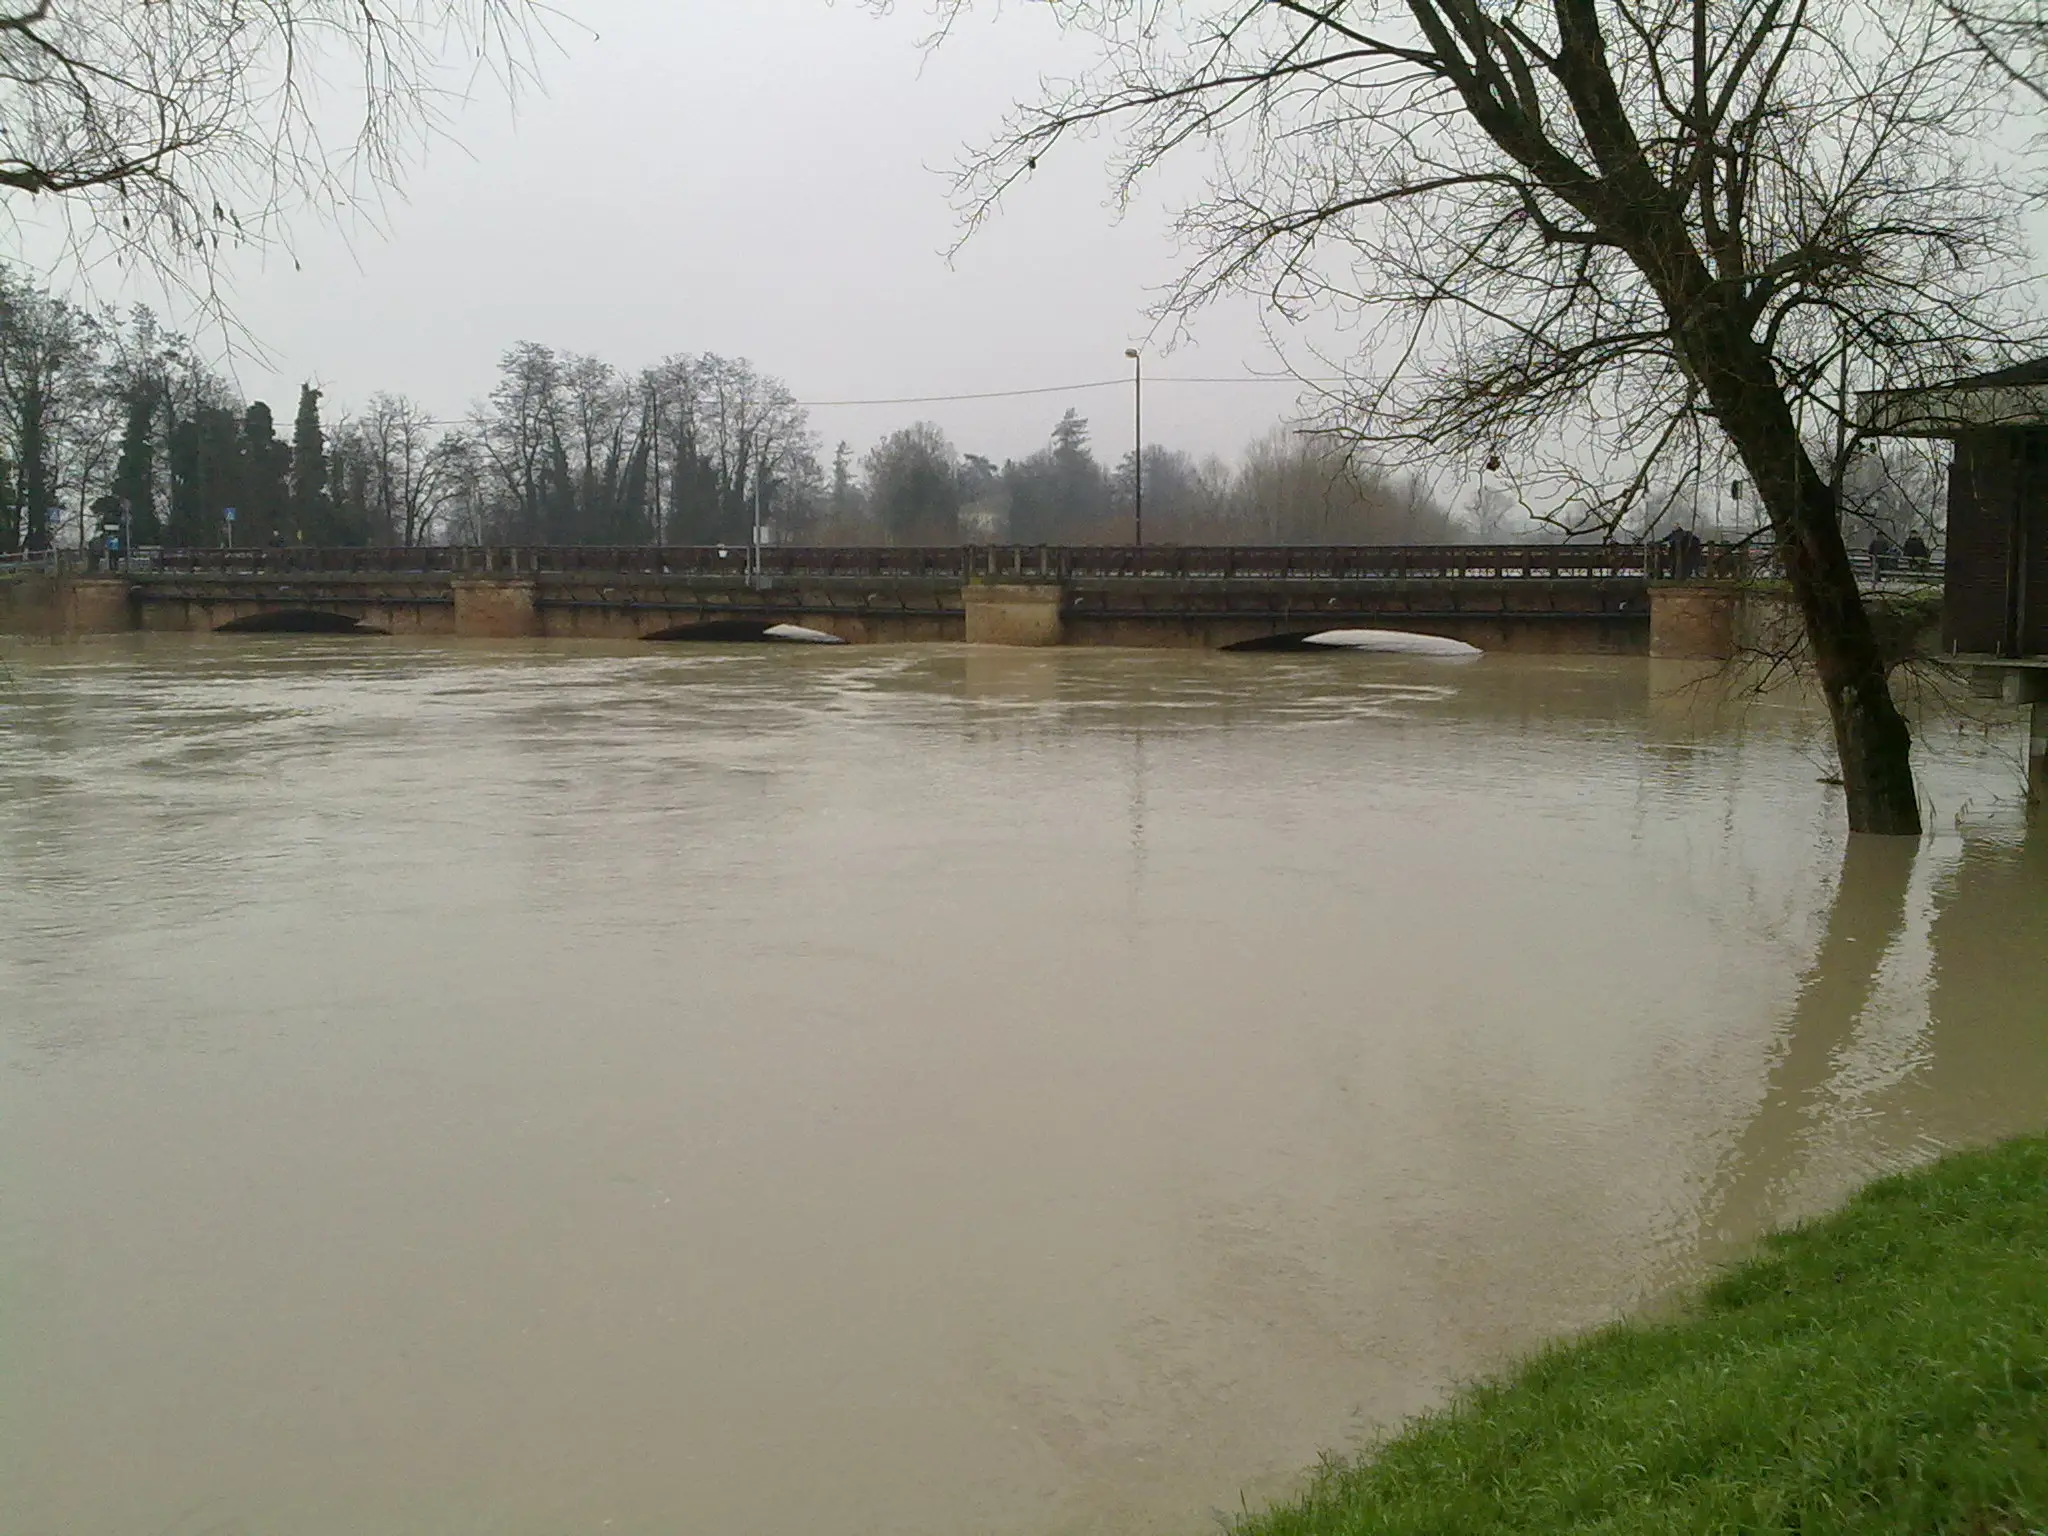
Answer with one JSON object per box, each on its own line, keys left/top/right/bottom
{"left": 0, "top": 545, "right": 1741, "bottom": 653}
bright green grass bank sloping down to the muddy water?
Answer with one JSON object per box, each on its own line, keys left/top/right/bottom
{"left": 1239, "top": 1137, "right": 2048, "bottom": 1536}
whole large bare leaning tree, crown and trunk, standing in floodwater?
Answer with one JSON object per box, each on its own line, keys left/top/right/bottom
{"left": 917, "top": 0, "right": 2048, "bottom": 834}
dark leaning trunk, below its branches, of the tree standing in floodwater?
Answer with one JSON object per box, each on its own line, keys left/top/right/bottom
{"left": 1686, "top": 326, "right": 1921, "bottom": 838}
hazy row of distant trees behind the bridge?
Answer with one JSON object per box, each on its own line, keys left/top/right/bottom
{"left": 0, "top": 270, "right": 1491, "bottom": 553}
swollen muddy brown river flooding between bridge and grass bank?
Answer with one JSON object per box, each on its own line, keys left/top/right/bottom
{"left": 0, "top": 637, "right": 2048, "bottom": 1536}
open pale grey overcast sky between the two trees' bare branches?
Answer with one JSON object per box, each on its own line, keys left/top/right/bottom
{"left": 203, "top": 0, "right": 1327, "bottom": 461}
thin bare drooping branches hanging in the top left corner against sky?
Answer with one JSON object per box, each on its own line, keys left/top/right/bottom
{"left": 0, "top": 0, "right": 547, "bottom": 281}
